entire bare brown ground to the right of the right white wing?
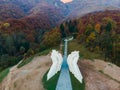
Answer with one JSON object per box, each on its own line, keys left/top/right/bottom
{"left": 78, "top": 60, "right": 120, "bottom": 90}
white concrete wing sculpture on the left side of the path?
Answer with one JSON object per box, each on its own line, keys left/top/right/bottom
{"left": 47, "top": 50, "right": 63, "bottom": 80}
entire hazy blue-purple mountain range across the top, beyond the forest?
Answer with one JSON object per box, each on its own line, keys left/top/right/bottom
{"left": 0, "top": 0, "right": 120, "bottom": 29}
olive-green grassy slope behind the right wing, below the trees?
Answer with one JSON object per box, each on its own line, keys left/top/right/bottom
{"left": 68, "top": 40, "right": 104, "bottom": 60}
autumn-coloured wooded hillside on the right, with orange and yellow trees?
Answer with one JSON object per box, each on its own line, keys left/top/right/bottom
{"left": 58, "top": 11, "right": 120, "bottom": 66}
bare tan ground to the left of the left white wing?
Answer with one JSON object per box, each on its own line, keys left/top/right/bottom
{"left": 0, "top": 56, "right": 51, "bottom": 90}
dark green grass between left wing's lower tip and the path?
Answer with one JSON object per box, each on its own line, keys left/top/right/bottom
{"left": 42, "top": 71, "right": 60, "bottom": 90}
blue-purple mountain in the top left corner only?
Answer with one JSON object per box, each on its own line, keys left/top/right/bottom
{"left": 0, "top": 0, "right": 37, "bottom": 21}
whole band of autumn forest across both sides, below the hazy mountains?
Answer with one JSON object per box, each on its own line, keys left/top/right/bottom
{"left": 0, "top": 11, "right": 120, "bottom": 71}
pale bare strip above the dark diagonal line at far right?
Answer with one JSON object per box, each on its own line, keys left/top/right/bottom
{"left": 91, "top": 59, "right": 120, "bottom": 82}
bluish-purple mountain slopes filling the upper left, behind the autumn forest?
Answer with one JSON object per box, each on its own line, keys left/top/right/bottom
{"left": 0, "top": 0, "right": 67, "bottom": 29}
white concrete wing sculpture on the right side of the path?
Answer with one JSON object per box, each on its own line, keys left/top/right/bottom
{"left": 67, "top": 51, "right": 83, "bottom": 83}
